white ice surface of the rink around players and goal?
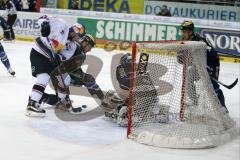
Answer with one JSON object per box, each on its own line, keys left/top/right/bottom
{"left": 0, "top": 41, "right": 240, "bottom": 160}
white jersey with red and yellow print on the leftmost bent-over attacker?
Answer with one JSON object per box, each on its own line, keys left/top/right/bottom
{"left": 33, "top": 16, "right": 69, "bottom": 58}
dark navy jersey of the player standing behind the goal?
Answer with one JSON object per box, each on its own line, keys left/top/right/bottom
{"left": 191, "top": 33, "right": 220, "bottom": 70}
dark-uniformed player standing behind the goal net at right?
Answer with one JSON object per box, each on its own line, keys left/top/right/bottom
{"left": 178, "top": 21, "right": 228, "bottom": 113}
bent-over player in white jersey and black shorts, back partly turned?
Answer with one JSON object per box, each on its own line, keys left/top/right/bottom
{"left": 27, "top": 16, "right": 69, "bottom": 116}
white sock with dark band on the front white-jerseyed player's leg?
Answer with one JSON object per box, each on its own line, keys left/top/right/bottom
{"left": 31, "top": 73, "right": 50, "bottom": 102}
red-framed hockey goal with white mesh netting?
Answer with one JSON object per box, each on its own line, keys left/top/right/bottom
{"left": 128, "top": 41, "right": 239, "bottom": 148}
